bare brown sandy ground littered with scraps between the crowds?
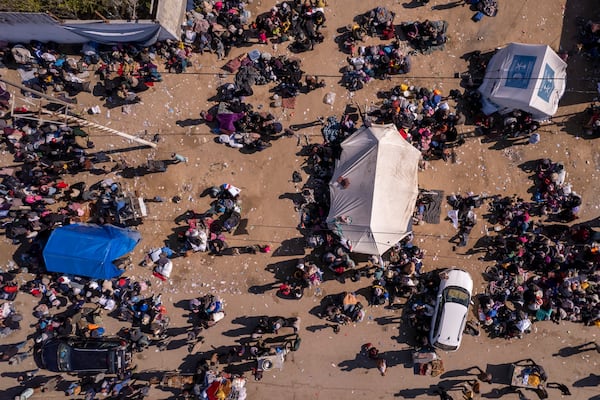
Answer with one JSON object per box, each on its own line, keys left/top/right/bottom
{"left": 0, "top": 0, "right": 600, "bottom": 400}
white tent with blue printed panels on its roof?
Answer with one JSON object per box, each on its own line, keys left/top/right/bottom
{"left": 478, "top": 43, "right": 567, "bottom": 120}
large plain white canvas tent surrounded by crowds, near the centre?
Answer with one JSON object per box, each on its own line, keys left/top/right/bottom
{"left": 327, "top": 124, "right": 421, "bottom": 254}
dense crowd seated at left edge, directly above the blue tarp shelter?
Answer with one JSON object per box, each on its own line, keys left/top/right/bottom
{"left": 0, "top": 119, "right": 110, "bottom": 247}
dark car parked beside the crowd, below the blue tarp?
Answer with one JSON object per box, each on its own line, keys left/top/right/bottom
{"left": 39, "top": 337, "right": 132, "bottom": 375}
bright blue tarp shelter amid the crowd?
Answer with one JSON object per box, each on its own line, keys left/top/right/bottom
{"left": 43, "top": 224, "right": 141, "bottom": 279}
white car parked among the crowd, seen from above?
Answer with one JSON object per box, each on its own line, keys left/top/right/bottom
{"left": 429, "top": 269, "right": 473, "bottom": 351}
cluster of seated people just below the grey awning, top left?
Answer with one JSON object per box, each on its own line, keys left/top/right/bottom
{"left": 5, "top": 41, "right": 168, "bottom": 107}
